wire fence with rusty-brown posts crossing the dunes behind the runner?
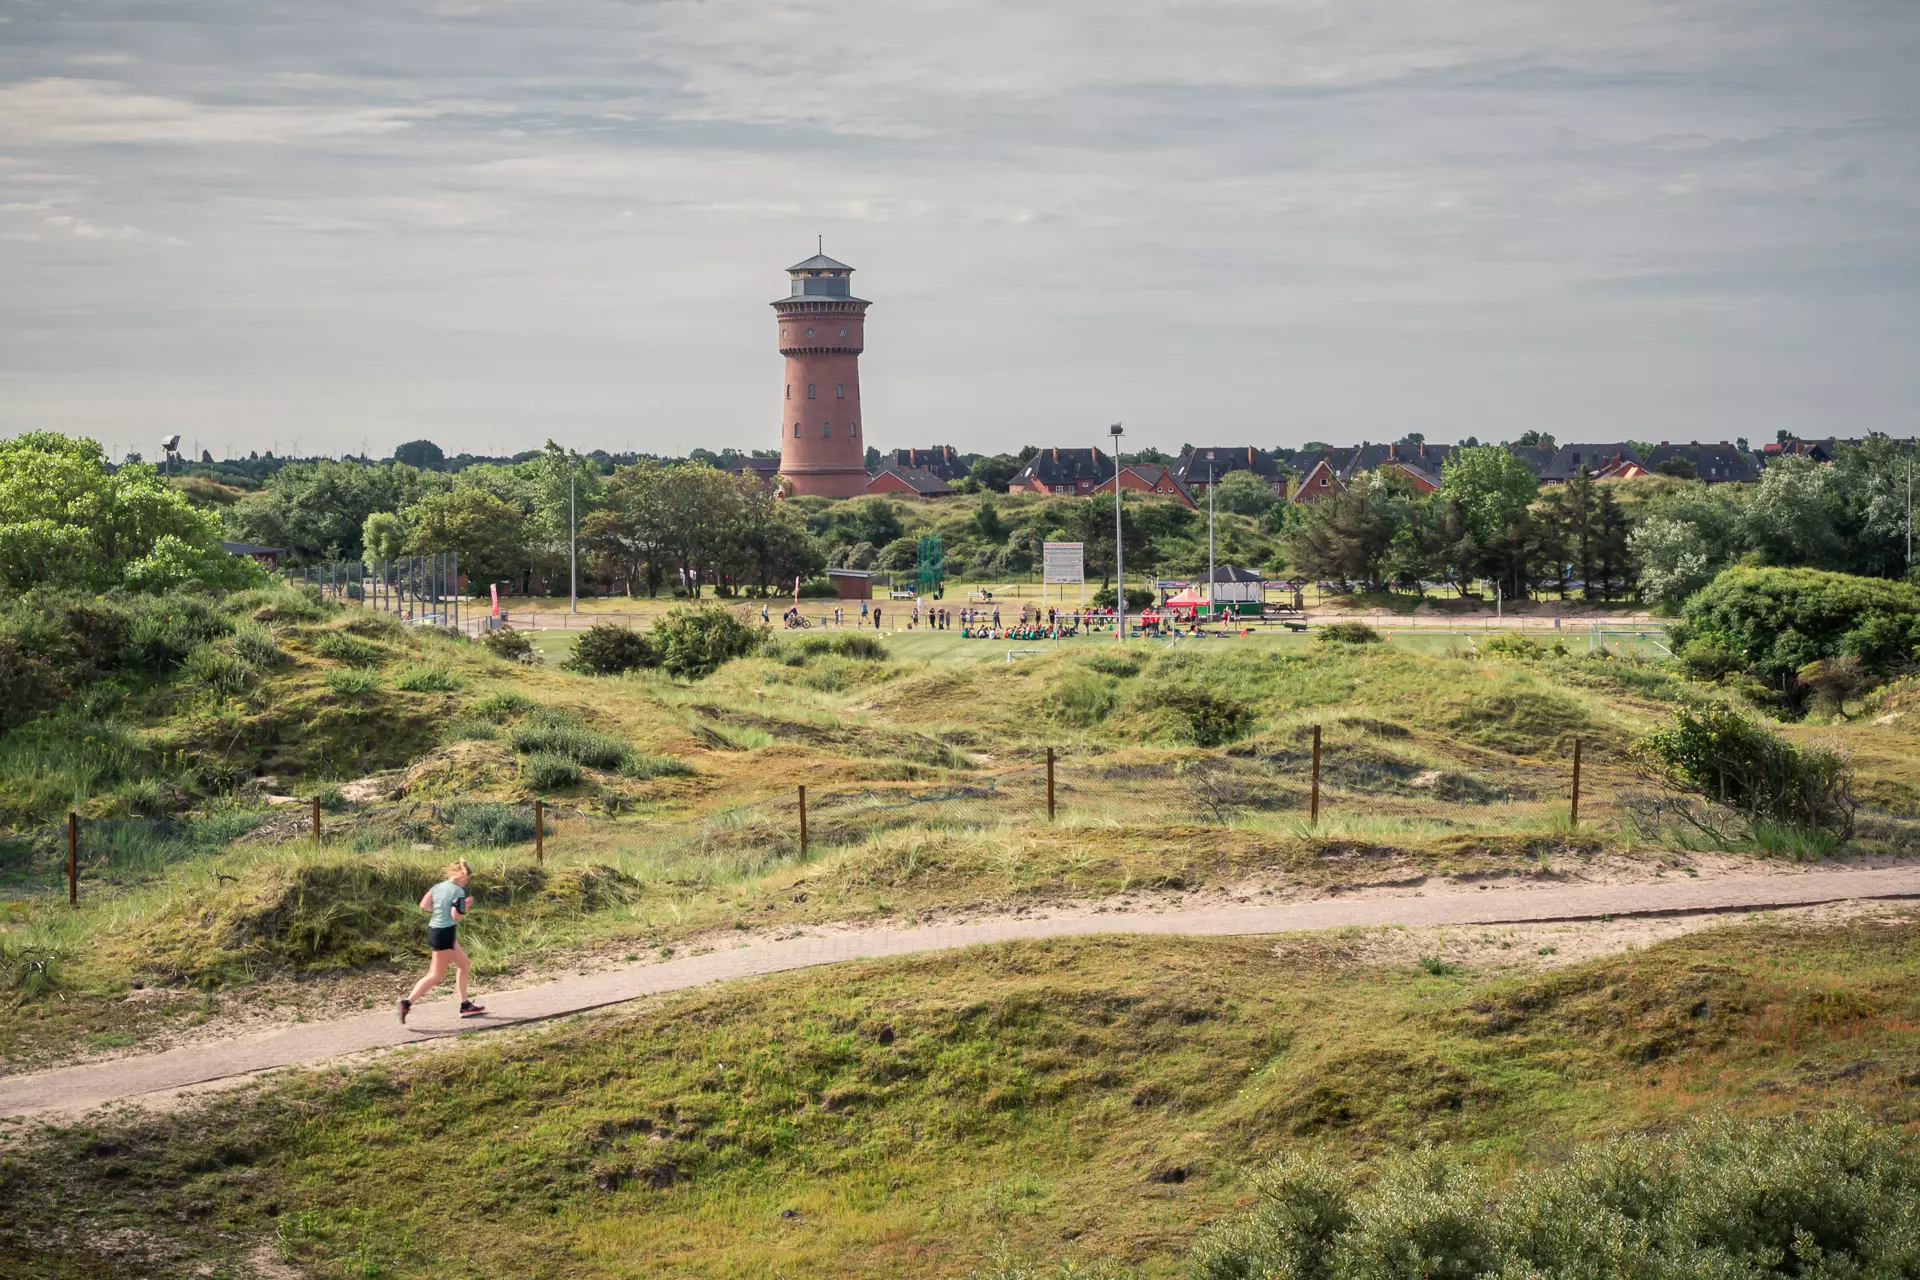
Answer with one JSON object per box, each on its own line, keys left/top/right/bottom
{"left": 15, "top": 718, "right": 1920, "bottom": 902}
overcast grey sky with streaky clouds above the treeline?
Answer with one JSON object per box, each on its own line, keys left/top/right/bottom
{"left": 0, "top": 0, "right": 1920, "bottom": 457}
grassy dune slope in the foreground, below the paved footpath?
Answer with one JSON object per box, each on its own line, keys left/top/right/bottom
{"left": 11, "top": 915, "right": 1920, "bottom": 1276}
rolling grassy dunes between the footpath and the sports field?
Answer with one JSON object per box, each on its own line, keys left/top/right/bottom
{"left": 0, "top": 610, "right": 1920, "bottom": 1071}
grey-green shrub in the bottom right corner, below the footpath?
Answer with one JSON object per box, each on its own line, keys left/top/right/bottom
{"left": 1187, "top": 1113, "right": 1920, "bottom": 1280}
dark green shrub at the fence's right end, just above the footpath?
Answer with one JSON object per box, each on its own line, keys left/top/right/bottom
{"left": 1630, "top": 702, "right": 1855, "bottom": 839}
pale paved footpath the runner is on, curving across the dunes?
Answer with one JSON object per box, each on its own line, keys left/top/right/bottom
{"left": 0, "top": 867, "right": 1920, "bottom": 1117}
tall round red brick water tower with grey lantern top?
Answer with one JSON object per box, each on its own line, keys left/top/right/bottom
{"left": 774, "top": 253, "right": 870, "bottom": 497}
